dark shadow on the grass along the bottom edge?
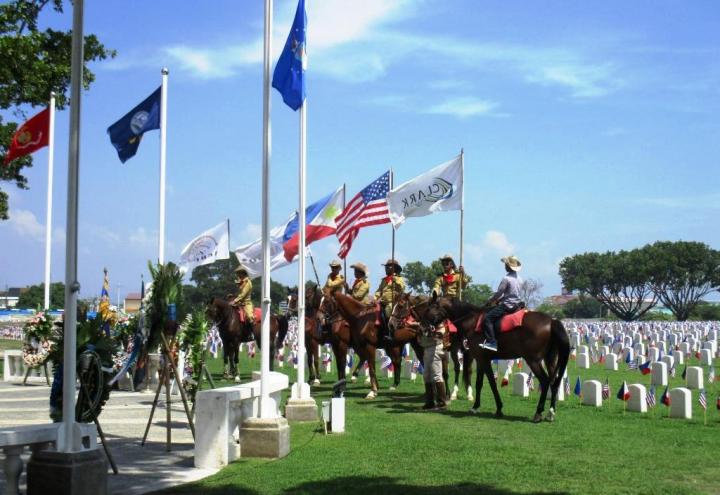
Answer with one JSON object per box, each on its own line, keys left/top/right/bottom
{"left": 158, "top": 476, "right": 567, "bottom": 495}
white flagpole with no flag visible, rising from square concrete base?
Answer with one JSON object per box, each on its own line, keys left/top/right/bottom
{"left": 258, "top": 0, "right": 274, "bottom": 419}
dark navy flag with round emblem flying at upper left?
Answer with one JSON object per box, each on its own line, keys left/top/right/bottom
{"left": 108, "top": 88, "right": 160, "bottom": 163}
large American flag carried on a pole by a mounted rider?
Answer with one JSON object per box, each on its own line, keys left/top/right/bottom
{"left": 335, "top": 171, "right": 390, "bottom": 258}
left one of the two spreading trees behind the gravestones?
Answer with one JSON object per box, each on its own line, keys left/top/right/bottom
{"left": 560, "top": 249, "right": 658, "bottom": 321}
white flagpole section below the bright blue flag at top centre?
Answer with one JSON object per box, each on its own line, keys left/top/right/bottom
{"left": 292, "top": 98, "right": 310, "bottom": 399}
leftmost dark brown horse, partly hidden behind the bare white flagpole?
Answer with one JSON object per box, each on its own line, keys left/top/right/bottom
{"left": 206, "top": 297, "right": 287, "bottom": 383}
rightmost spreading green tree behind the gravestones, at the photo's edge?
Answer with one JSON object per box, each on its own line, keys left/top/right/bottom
{"left": 643, "top": 241, "right": 720, "bottom": 321}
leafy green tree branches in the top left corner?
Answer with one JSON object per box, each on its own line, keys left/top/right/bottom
{"left": 0, "top": 0, "right": 115, "bottom": 220}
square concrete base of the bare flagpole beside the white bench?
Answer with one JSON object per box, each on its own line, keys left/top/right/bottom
{"left": 240, "top": 418, "right": 290, "bottom": 459}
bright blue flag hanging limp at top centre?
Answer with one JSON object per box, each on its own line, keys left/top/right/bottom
{"left": 273, "top": 0, "right": 307, "bottom": 110}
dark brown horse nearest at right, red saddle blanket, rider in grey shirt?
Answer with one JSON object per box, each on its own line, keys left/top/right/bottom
{"left": 423, "top": 292, "right": 570, "bottom": 423}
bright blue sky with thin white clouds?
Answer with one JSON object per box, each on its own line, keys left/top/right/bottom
{"left": 0, "top": 0, "right": 720, "bottom": 302}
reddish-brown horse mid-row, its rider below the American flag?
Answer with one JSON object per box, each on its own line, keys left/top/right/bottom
{"left": 320, "top": 292, "right": 422, "bottom": 399}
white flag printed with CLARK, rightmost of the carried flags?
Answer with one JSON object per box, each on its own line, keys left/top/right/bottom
{"left": 387, "top": 155, "right": 463, "bottom": 228}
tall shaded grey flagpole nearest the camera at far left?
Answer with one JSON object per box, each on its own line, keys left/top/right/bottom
{"left": 57, "top": 0, "right": 84, "bottom": 453}
